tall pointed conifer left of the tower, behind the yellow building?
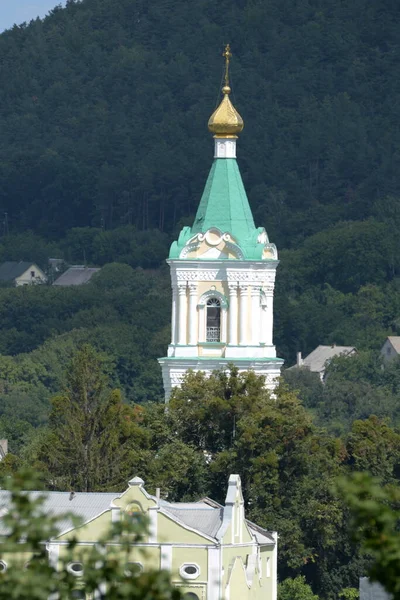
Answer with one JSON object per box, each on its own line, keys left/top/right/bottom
{"left": 37, "top": 345, "right": 146, "bottom": 491}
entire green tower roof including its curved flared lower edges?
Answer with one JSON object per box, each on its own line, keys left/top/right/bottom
{"left": 169, "top": 158, "right": 276, "bottom": 260}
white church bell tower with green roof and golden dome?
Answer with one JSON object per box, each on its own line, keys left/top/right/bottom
{"left": 158, "top": 44, "right": 283, "bottom": 401}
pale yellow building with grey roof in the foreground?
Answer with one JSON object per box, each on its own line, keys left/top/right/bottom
{"left": 0, "top": 475, "right": 277, "bottom": 600}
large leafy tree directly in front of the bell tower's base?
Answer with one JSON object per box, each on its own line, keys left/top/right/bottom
{"left": 162, "top": 367, "right": 350, "bottom": 596}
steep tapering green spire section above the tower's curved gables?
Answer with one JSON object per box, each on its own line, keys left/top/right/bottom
{"left": 192, "top": 158, "right": 256, "bottom": 240}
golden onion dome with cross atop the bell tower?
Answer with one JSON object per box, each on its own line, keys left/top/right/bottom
{"left": 208, "top": 44, "right": 244, "bottom": 137}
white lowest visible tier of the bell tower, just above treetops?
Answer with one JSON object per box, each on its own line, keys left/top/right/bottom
{"left": 158, "top": 357, "right": 283, "bottom": 402}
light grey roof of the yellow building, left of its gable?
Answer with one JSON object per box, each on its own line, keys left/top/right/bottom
{"left": 0, "top": 490, "right": 118, "bottom": 535}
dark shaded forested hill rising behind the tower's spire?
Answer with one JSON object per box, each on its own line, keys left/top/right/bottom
{"left": 0, "top": 0, "right": 400, "bottom": 241}
